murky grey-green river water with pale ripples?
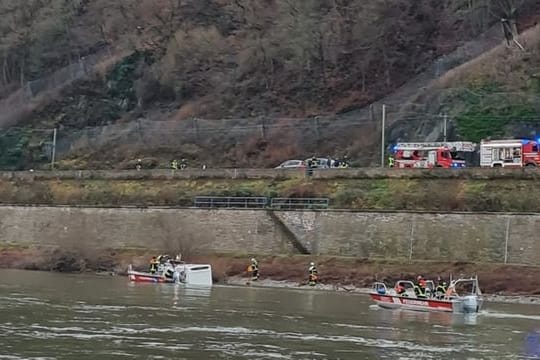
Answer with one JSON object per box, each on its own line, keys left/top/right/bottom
{"left": 0, "top": 270, "right": 540, "bottom": 360}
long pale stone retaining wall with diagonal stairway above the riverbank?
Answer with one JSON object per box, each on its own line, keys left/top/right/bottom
{"left": 0, "top": 206, "right": 540, "bottom": 268}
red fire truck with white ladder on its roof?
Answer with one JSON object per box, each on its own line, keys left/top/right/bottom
{"left": 393, "top": 142, "right": 476, "bottom": 169}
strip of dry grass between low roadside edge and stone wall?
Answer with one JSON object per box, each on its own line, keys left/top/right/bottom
{"left": 0, "top": 173, "right": 540, "bottom": 212}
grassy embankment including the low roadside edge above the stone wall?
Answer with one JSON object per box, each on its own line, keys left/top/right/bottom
{"left": 0, "top": 168, "right": 540, "bottom": 213}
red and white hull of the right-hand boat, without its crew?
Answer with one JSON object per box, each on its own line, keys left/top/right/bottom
{"left": 370, "top": 294, "right": 480, "bottom": 313}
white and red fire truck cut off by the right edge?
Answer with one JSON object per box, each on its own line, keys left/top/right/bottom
{"left": 480, "top": 139, "right": 540, "bottom": 167}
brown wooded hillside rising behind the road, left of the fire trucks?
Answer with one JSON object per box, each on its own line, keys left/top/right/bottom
{"left": 0, "top": 0, "right": 537, "bottom": 168}
